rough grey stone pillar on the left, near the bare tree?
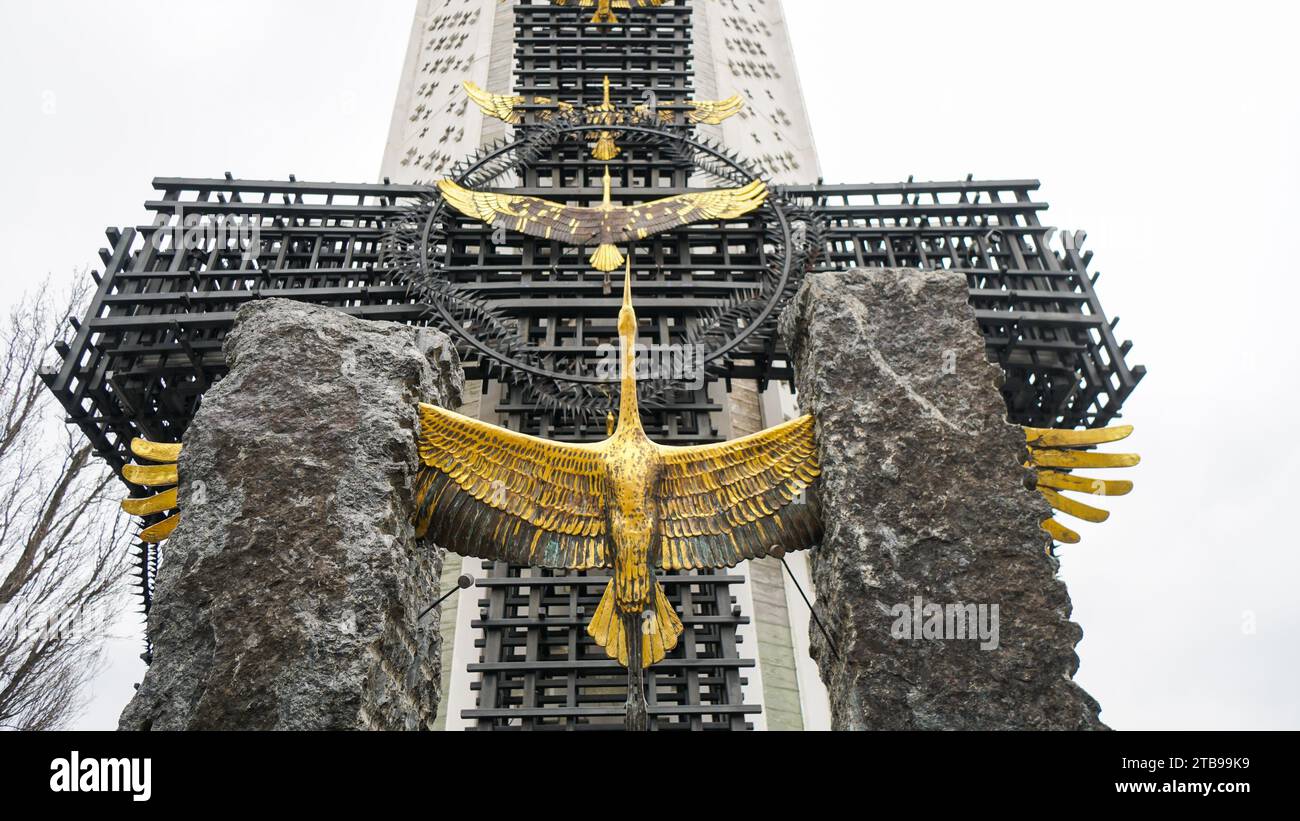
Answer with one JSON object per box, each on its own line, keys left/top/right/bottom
{"left": 120, "top": 299, "right": 464, "bottom": 730}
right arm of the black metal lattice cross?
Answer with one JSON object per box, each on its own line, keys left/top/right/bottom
{"left": 785, "top": 179, "right": 1147, "bottom": 427}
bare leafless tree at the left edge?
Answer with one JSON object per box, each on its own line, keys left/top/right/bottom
{"left": 0, "top": 277, "right": 130, "bottom": 730}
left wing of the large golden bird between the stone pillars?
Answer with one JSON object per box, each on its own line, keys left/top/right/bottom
{"left": 416, "top": 404, "right": 612, "bottom": 570}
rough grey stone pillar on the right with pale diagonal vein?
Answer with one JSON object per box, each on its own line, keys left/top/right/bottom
{"left": 781, "top": 269, "right": 1104, "bottom": 730}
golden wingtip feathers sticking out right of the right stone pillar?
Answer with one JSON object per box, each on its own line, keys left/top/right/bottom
{"left": 1024, "top": 425, "right": 1140, "bottom": 544}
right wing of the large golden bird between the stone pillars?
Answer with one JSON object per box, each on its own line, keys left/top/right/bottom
{"left": 659, "top": 416, "right": 822, "bottom": 570}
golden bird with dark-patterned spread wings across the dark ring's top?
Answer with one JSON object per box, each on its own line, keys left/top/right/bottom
{"left": 438, "top": 168, "right": 767, "bottom": 273}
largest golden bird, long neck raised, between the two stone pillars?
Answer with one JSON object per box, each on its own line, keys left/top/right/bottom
{"left": 415, "top": 262, "right": 822, "bottom": 730}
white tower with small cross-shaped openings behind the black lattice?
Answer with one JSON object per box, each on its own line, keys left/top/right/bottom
{"left": 381, "top": 0, "right": 820, "bottom": 184}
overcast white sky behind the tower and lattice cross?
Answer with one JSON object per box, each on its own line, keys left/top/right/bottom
{"left": 0, "top": 0, "right": 1300, "bottom": 729}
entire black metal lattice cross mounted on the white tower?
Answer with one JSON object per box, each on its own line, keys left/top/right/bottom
{"left": 44, "top": 3, "right": 1144, "bottom": 729}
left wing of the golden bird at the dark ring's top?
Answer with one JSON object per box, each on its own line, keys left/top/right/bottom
{"left": 438, "top": 179, "right": 603, "bottom": 246}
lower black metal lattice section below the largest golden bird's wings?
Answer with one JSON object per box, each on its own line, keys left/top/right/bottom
{"left": 462, "top": 564, "right": 759, "bottom": 730}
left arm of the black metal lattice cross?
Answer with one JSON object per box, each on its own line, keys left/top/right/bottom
{"left": 43, "top": 177, "right": 423, "bottom": 470}
